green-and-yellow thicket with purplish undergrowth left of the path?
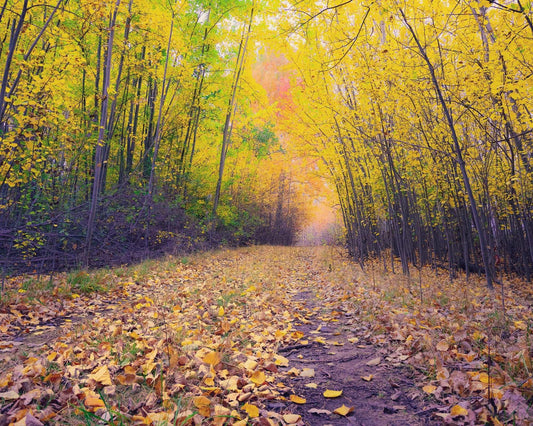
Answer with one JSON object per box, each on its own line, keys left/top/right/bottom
{"left": 0, "top": 0, "right": 306, "bottom": 268}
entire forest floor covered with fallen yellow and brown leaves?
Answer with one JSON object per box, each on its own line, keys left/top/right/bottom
{"left": 0, "top": 247, "right": 533, "bottom": 425}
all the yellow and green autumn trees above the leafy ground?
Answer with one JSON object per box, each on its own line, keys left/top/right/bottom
{"left": 0, "top": 0, "right": 533, "bottom": 287}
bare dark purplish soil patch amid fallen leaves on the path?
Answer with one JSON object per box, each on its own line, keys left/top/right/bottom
{"left": 268, "top": 291, "right": 443, "bottom": 426}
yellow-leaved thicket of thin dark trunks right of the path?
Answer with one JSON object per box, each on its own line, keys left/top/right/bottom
{"left": 280, "top": 0, "right": 533, "bottom": 286}
